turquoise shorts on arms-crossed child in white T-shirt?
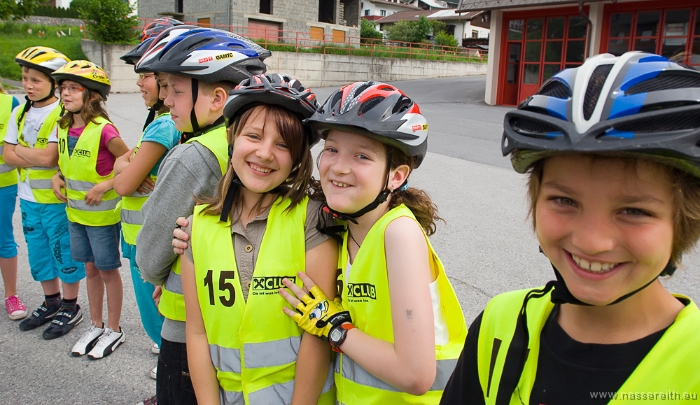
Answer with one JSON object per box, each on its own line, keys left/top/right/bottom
{"left": 19, "top": 199, "right": 85, "bottom": 284}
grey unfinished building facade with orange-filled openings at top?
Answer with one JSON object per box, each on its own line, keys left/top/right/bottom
{"left": 138, "top": 0, "right": 360, "bottom": 40}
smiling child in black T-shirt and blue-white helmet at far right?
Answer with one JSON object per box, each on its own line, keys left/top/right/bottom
{"left": 442, "top": 52, "right": 700, "bottom": 405}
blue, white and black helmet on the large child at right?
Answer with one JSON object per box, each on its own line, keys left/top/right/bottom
{"left": 501, "top": 52, "right": 700, "bottom": 177}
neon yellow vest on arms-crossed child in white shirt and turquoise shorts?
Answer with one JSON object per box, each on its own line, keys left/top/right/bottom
{"left": 16, "top": 103, "right": 63, "bottom": 204}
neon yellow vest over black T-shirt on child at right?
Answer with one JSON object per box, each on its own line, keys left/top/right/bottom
{"left": 477, "top": 290, "right": 700, "bottom": 405}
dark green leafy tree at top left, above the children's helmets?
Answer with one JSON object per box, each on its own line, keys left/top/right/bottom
{"left": 78, "top": 0, "right": 138, "bottom": 44}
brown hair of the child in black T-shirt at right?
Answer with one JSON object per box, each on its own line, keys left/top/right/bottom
{"left": 528, "top": 154, "right": 700, "bottom": 266}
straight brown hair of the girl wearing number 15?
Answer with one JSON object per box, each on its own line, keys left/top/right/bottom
{"left": 198, "top": 104, "right": 313, "bottom": 223}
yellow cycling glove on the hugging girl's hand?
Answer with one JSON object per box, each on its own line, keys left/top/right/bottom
{"left": 293, "top": 286, "right": 352, "bottom": 340}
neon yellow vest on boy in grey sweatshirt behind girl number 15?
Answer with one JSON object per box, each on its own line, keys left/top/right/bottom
{"left": 158, "top": 124, "right": 228, "bottom": 322}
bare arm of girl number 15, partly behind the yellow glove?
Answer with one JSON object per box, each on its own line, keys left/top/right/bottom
{"left": 292, "top": 238, "right": 338, "bottom": 405}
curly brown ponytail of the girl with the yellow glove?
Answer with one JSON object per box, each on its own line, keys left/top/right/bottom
{"left": 386, "top": 145, "right": 445, "bottom": 236}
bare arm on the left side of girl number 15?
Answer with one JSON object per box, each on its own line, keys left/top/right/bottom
{"left": 180, "top": 251, "right": 219, "bottom": 404}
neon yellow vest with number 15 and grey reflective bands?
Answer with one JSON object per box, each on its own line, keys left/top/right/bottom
{"left": 192, "top": 198, "right": 335, "bottom": 405}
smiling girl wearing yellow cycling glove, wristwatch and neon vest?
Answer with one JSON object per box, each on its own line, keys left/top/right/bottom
{"left": 280, "top": 82, "right": 466, "bottom": 405}
